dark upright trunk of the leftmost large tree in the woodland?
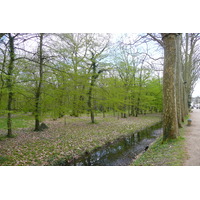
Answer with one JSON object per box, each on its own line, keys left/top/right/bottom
{"left": 7, "top": 33, "right": 15, "bottom": 137}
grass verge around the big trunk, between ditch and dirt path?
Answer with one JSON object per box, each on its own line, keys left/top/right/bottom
{"left": 132, "top": 122, "right": 187, "bottom": 166}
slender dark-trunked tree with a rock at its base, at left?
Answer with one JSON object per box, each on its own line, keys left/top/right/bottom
{"left": 15, "top": 33, "right": 50, "bottom": 131}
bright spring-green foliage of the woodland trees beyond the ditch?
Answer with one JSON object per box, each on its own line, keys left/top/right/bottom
{"left": 0, "top": 33, "right": 162, "bottom": 129}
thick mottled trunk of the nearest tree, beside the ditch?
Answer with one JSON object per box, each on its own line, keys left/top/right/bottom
{"left": 162, "top": 33, "right": 178, "bottom": 140}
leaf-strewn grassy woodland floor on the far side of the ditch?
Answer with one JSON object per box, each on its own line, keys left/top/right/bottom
{"left": 0, "top": 112, "right": 161, "bottom": 166}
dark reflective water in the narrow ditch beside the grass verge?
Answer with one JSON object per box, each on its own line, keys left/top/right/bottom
{"left": 66, "top": 124, "right": 162, "bottom": 166}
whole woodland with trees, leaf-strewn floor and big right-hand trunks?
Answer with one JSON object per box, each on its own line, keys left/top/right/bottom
{"left": 0, "top": 33, "right": 200, "bottom": 165}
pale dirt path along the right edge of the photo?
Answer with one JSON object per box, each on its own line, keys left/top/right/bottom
{"left": 184, "top": 109, "right": 200, "bottom": 166}
